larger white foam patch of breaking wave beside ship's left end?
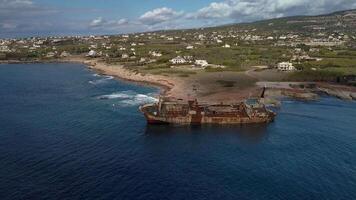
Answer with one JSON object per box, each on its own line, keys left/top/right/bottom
{"left": 97, "top": 90, "right": 158, "bottom": 106}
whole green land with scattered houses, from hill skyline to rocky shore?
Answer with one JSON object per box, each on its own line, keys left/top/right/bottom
{"left": 0, "top": 11, "right": 356, "bottom": 100}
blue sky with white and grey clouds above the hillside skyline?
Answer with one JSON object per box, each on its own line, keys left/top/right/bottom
{"left": 0, "top": 0, "right": 356, "bottom": 38}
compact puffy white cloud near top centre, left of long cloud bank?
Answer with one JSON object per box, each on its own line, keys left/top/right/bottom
{"left": 139, "top": 7, "right": 183, "bottom": 25}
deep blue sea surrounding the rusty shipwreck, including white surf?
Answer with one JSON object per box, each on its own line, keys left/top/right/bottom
{"left": 0, "top": 64, "right": 356, "bottom": 200}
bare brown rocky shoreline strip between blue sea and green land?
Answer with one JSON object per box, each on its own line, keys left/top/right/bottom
{"left": 0, "top": 56, "right": 356, "bottom": 104}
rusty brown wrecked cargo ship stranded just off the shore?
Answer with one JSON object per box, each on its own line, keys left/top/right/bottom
{"left": 140, "top": 98, "right": 276, "bottom": 124}
